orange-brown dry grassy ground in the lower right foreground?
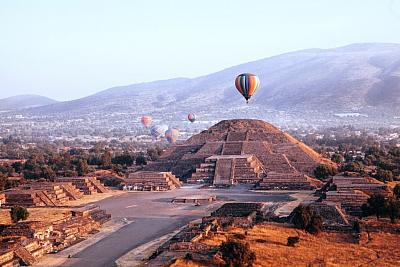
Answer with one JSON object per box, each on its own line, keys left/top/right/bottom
{"left": 171, "top": 223, "right": 400, "bottom": 267}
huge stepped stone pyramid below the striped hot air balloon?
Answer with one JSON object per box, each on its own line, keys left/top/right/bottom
{"left": 144, "top": 120, "right": 334, "bottom": 190}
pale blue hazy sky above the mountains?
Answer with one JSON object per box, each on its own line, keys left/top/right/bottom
{"left": 0, "top": 0, "right": 400, "bottom": 100}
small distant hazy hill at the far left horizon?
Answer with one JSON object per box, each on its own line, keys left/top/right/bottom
{"left": 0, "top": 95, "right": 57, "bottom": 111}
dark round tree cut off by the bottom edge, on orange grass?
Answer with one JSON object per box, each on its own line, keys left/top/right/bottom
{"left": 219, "top": 240, "right": 256, "bottom": 267}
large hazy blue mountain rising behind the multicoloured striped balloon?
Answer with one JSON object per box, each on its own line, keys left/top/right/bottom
{"left": 13, "top": 43, "right": 400, "bottom": 122}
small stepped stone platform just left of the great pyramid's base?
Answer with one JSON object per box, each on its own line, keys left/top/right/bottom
{"left": 124, "top": 171, "right": 181, "bottom": 191}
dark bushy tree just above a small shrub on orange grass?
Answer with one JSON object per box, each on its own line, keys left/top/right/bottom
{"left": 289, "top": 205, "right": 323, "bottom": 234}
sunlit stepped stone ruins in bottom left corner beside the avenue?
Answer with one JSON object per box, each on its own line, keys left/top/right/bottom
{"left": 0, "top": 205, "right": 111, "bottom": 266}
